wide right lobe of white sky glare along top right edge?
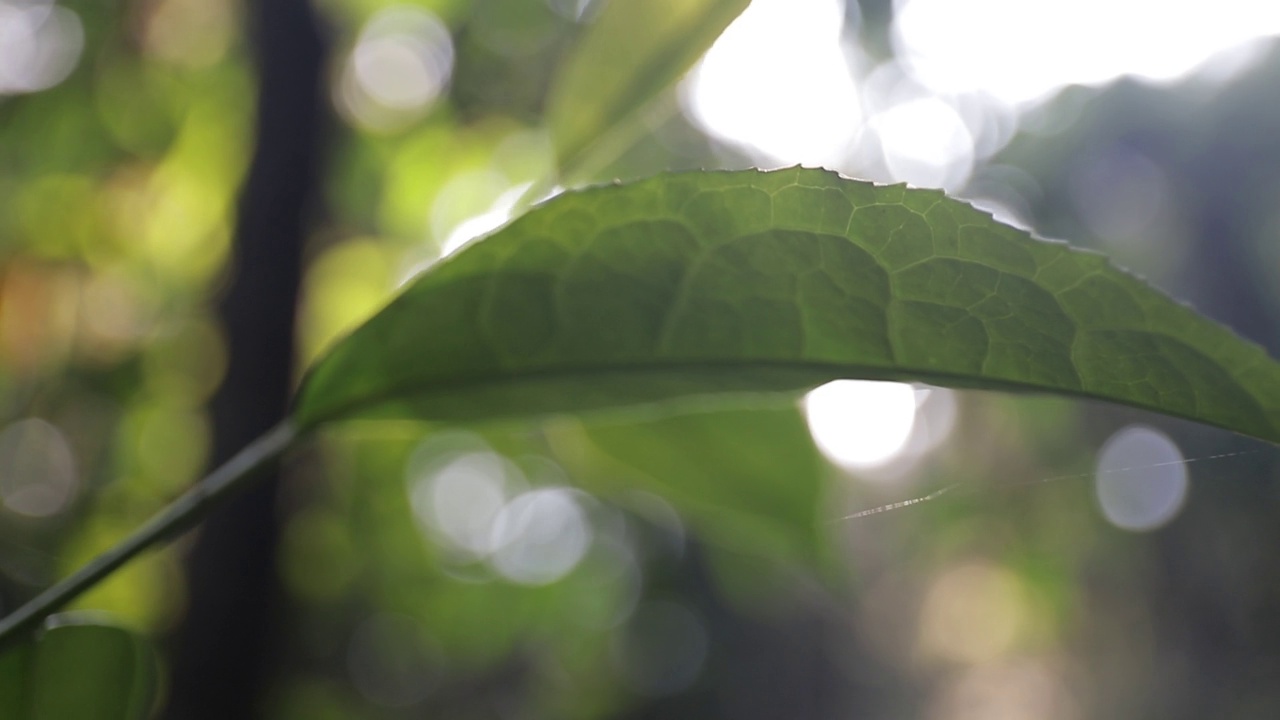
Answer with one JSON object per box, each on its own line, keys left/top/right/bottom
{"left": 895, "top": 0, "right": 1280, "bottom": 105}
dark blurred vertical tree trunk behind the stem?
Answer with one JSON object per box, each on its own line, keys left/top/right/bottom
{"left": 165, "top": 0, "right": 325, "bottom": 720}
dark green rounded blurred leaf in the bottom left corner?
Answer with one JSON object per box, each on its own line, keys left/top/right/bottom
{"left": 0, "top": 614, "right": 156, "bottom": 720}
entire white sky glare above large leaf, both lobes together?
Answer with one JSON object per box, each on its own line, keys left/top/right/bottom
{"left": 681, "top": 0, "right": 1280, "bottom": 191}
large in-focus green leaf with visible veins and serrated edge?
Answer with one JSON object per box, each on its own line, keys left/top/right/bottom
{"left": 294, "top": 168, "right": 1280, "bottom": 442}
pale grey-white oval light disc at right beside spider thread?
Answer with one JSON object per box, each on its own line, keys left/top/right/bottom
{"left": 1097, "top": 425, "right": 1188, "bottom": 530}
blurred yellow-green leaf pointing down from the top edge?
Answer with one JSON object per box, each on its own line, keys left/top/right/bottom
{"left": 547, "top": 0, "right": 750, "bottom": 177}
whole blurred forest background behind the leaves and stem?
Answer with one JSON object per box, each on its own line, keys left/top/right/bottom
{"left": 0, "top": 0, "right": 1280, "bottom": 720}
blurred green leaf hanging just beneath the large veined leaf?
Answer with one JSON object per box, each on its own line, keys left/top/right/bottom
{"left": 558, "top": 404, "right": 826, "bottom": 565}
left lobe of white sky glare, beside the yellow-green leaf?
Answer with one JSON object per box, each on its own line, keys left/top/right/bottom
{"left": 684, "top": 0, "right": 861, "bottom": 167}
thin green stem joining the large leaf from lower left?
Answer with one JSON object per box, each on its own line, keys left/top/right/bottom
{"left": 0, "top": 420, "right": 298, "bottom": 646}
